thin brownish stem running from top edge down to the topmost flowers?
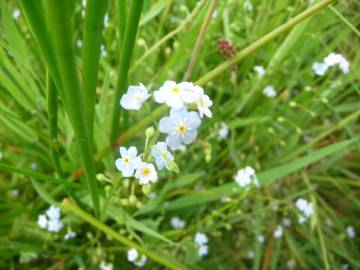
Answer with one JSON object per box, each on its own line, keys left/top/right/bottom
{"left": 184, "top": 0, "right": 219, "bottom": 81}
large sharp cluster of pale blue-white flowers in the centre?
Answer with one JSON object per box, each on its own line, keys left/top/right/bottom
{"left": 115, "top": 81, "right": 212, "bottom": 185}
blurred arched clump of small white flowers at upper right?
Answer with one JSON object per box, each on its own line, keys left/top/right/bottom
{"left": 312, "top": 52, "right": 350, "bottom": 76}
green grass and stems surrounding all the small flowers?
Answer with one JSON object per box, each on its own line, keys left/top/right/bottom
{"left": 0, "top": 0, "right": 360, "bottom": 270}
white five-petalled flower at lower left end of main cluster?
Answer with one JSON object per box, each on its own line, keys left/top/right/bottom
{"left": 115, "top": 146, "right": 141, "bottom": 177}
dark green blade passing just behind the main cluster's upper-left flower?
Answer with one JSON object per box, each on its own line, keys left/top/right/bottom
{"left": 110, "top": 0, "right": 144, "bottom": 142}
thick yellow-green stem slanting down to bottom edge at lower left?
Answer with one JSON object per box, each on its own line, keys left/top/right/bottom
{"left": 61, "top": 199, "right": 188, "bottom": 270}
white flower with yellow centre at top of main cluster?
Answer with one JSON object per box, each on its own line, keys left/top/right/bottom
{"left": 154, "top": 81, "right": 195, "bottom": 109}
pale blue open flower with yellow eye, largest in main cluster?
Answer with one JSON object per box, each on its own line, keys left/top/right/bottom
{"left": 159, "top": 108, "right": 201, "bottom": 148}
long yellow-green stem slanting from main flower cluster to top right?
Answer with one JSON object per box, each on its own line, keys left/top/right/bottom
{"left": 195, "top": 0, "right": 336, "bottom": 85}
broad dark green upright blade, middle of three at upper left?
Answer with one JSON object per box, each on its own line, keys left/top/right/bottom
{"left": 82, "top": 0, "right": 109, "bottom": 141}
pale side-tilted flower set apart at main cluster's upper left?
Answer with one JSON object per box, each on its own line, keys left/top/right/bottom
{"left": 120, "top": 83, "right": 151, "bottom": 110}
